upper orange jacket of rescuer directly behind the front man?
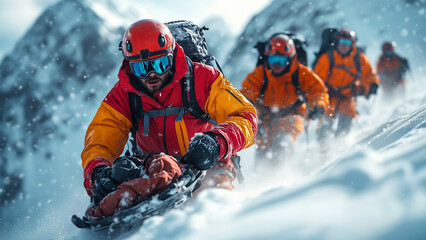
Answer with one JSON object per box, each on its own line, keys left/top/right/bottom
{"left": 241, "top": 59, "right": 328, "bottom": 115}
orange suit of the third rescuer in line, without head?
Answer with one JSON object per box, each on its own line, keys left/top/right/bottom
{"left": 315, "top": 44, "right": 380, "bottom": 117}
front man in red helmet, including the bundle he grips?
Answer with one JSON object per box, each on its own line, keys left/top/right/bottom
{"left": 81, "top": 19, "right": 257, "bottom": 219}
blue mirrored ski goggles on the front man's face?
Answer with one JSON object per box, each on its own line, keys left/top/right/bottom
{"left": 130, "top": 54, "right": 173, "bottom": 78}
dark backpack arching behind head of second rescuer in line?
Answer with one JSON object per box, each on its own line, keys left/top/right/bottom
{"left": 254, "top": 31, "right": 308, "bottom": 66}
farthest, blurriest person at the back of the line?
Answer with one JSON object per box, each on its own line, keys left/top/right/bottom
{"left": 377, "top": 42, "right": 409, "bottom": 96}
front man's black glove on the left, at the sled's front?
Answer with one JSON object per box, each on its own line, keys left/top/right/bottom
{"left": 91, "top": 166, "right": 117, "bottom": 205}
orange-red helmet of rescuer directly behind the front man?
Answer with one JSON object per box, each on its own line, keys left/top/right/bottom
{"left": 265, "top": 34, "right": 296, "bottom": 58}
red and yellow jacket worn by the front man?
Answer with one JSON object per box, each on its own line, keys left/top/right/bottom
{"left": 81, "top": 45, "right": 257, "bottom": 195}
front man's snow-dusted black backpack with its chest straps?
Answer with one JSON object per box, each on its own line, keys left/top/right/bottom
{"left": 128, "top": 20, "right": 221, "bottom": 155}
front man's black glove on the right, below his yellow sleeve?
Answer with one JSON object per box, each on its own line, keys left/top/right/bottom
{"left": 180, "top": 133, "right": 220, "bottom": 170}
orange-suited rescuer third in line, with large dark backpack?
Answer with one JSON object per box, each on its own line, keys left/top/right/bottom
{"left": 315, "top": 29, "right": 380, "bottom": 139}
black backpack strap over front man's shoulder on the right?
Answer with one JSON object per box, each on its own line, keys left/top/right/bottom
{"left": 180, "top": 57, "right": 217, "bottom": 125}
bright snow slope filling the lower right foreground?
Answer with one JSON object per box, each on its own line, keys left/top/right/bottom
{"left": 117, "top": 83, "right": 426, "bottom": 239}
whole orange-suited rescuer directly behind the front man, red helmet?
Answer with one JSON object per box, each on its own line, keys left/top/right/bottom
{"left": 241, "top": 34, "right": 328, "bottom": 164}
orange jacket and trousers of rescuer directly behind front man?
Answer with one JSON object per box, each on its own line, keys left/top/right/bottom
{"left": 241, "top": 59, "right": 328, "bottom": 144}
